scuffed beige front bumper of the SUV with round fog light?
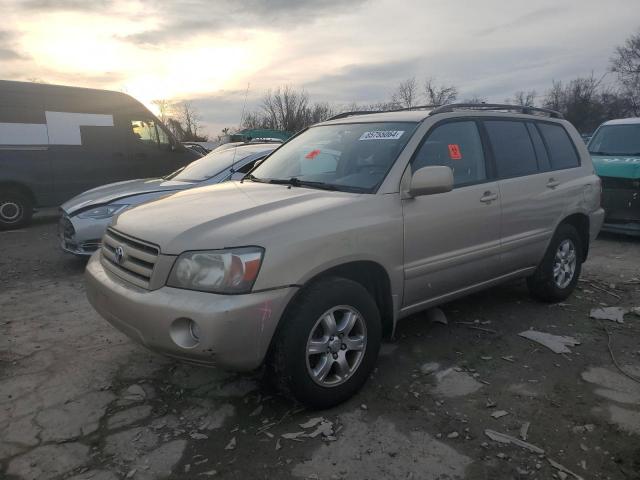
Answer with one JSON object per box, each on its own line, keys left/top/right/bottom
{"left": 85, "top": 252, "right": 296, "bottom": 370}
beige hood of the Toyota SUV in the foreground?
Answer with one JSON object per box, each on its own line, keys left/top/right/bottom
{"left": 113, "top": 182, "right": 364, "bottom": 255}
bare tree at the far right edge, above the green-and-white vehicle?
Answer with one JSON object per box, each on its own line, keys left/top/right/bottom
{"left": 611, "top": 31, "right": 640, "bottom": 116}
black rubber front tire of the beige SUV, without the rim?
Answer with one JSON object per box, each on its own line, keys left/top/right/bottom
{"left": 269, "top": 277, "right": 382, "bottom": 408}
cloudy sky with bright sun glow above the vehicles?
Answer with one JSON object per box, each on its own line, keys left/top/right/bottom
{"left": 0, "top": 0, "right": 640, "bottom": 136}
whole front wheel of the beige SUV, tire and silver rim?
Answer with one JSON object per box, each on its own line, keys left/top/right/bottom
{"left": 270, "top": 277, "right": 382, "bottom": 408}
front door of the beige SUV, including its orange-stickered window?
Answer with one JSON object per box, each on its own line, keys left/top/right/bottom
{"left": 402, "top": 119, "right": 500, "bottom": 307}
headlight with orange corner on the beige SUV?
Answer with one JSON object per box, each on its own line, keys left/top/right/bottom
{"left": 167, "top": 247, "right": 264, "bottom": 293}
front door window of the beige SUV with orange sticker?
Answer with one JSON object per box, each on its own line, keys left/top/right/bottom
{"left": 411, "top": 122, "right": 487, "bottom": 185}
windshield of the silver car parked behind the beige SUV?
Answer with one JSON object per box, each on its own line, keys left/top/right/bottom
{"left": 165, "top": 145, "right": 275, "bottom": 182}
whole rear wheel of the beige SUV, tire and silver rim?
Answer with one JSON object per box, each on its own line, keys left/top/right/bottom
{"left": 527, "top": 224, "right": 583, "bottom": 302}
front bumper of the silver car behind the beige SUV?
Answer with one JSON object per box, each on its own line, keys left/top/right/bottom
{"left": 58, "top": 214, "right": 112, "bottom": 257}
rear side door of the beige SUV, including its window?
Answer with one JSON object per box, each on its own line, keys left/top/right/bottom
{"left": 483, "top": 118, "right": 566, "bottom": 273}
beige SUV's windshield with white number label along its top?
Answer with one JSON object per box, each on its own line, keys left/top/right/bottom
{"left": 249, "top": 122, "right": 416, "bottom": 193}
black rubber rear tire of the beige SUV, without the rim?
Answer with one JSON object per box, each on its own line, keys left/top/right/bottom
{"left": 527, "top": 224, "right": 584, "bottom": 303}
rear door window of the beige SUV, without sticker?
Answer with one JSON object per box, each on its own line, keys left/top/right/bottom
{"left": 484, "top": 120, "right": 538, "bottom": 178}
